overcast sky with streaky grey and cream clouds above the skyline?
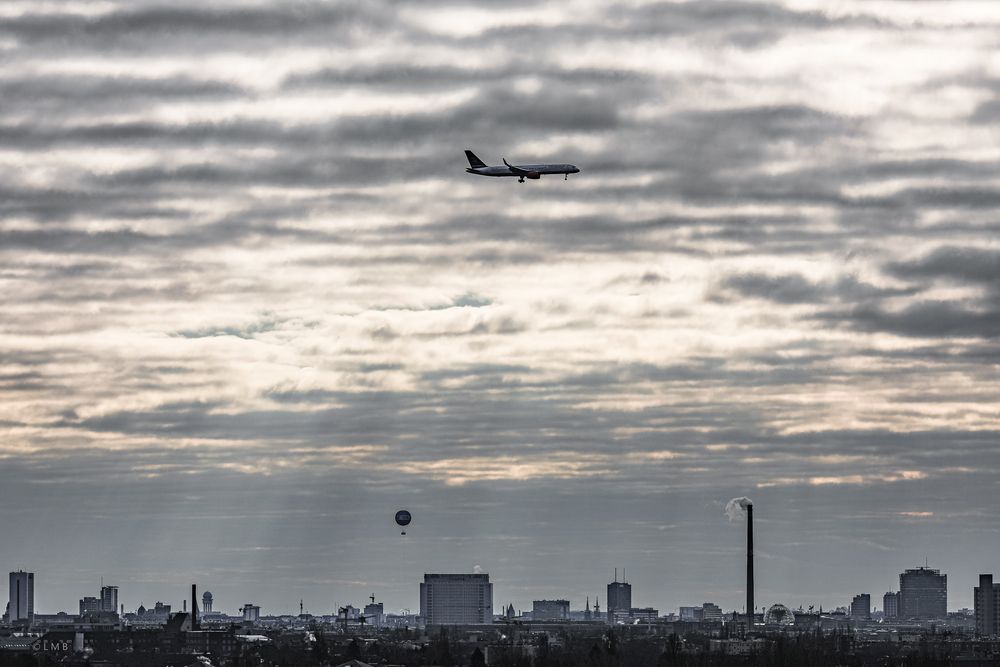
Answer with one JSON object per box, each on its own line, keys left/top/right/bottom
{"left": 0, "top": 0, "right": 1000, "bottom": 613}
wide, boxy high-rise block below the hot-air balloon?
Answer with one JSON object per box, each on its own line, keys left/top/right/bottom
{"left": 420, "top": 574, "right": 493, "bottom": 625}
